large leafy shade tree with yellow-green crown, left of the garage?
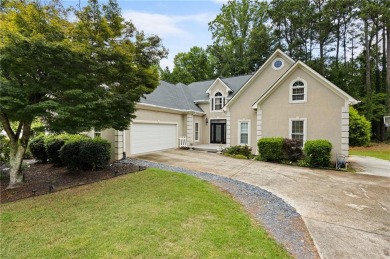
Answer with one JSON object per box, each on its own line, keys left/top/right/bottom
{"left": 0, "top": 0, "right": 167, "bottom": 187}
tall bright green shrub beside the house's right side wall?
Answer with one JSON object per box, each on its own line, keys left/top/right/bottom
{"left": 349, "top": 107, "right": 371, "bottom": 146}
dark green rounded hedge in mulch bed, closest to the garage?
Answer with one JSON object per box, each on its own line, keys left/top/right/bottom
{"left": 60, "top": 137, "right": 111, "bottom": 170}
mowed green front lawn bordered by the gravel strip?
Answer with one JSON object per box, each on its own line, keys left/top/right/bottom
{"left": 0, "top": 169, "right": 290, "bottom": 258}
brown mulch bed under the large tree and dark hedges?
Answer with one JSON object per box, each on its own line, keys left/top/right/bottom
{"left": 0, "top": 161, "right": 146, "bottom": 203}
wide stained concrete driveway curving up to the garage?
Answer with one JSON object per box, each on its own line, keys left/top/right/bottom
{"left": 135, "top": 150, "right": 390, "bottom": 258}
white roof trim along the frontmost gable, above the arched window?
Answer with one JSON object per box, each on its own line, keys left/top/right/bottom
{"left": 252, "top": 61, "right": 359, "bottom": 109}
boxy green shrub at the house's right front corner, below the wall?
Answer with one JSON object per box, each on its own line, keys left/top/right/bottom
{"left": 304, "top": 139, "right": 332, "bottom": 167}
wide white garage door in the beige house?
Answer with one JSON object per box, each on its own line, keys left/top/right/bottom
{"left": 131, "top": 123, "right": 177, "bottom": 154}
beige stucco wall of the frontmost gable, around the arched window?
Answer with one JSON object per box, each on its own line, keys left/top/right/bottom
{"left": 258, "top": 68, "right": 345, "bottom": 159}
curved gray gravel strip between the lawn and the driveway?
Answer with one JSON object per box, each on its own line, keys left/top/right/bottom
{"left": 121, "top": 158, "right": 319, "bottom": 258}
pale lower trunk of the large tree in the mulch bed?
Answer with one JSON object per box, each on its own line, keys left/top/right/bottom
{"left": 7, "top": 142, "right": 26, "bottom": 189}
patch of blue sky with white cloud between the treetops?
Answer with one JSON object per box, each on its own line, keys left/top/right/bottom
{"left": 65, "top": 0, "right": 227, "bottom": 70}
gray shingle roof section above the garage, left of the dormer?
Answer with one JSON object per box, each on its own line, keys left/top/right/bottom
{"left": 140, "top": 81, "right": 203, "bottom": 112}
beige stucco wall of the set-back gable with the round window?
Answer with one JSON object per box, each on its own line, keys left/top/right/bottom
{"left": 228, "top": 55, "right": 291, "bottom": 152}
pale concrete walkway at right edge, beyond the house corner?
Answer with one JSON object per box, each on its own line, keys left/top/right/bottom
{"left": 348, "top": 156, "right": 390, "bottom": 177}
